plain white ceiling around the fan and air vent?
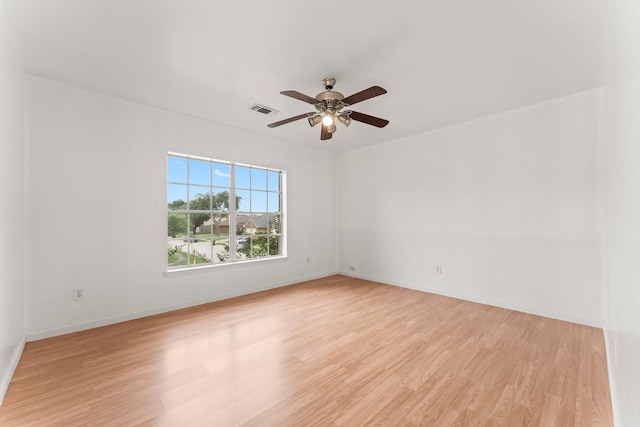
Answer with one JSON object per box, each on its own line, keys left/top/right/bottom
{"left": 4, "top": 0, "right": 606, "bottom": 152}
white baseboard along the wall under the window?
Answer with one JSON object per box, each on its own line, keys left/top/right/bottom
{"left": 27, "top": 271, "right": 338, "bottom": 341}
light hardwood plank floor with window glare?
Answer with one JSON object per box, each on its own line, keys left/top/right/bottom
{"left": 0, "top": 276, "right": 613, "bottom": 427}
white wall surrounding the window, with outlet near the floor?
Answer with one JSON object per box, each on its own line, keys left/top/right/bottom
{"left": 25, "top": 77, "right": 336, "bottom": 339}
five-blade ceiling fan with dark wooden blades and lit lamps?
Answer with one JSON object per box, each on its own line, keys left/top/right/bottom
{"left": 267, "top": 77, "right": 389, "bottom": 140}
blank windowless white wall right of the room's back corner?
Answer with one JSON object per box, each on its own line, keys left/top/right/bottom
{"left": 337, "top": 90, "right": 603, "bottom": 326}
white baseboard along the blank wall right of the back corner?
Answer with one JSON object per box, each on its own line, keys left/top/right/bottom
{"left": 338, "top": 271, "right": 602, "bottom": 328}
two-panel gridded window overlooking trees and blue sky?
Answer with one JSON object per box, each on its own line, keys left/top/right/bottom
{"left": 167, "top": 153, "right": 284, "bottom": 269}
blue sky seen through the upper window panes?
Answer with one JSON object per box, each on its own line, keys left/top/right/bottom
{"left": 167, "top": 156, "right": 280, "bottom": 212}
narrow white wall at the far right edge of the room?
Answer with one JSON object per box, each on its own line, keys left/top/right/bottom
{"left": 604, "top": 0, "right": 640, "bottom": 426}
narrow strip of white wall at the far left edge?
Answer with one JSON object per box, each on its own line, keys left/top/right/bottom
{"left": 0, "top": 2, "right": 24, "bottom": 403}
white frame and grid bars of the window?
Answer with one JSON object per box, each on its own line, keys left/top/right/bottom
{"left": 164, "top": 151, "right": 287, "bottom": 273}
